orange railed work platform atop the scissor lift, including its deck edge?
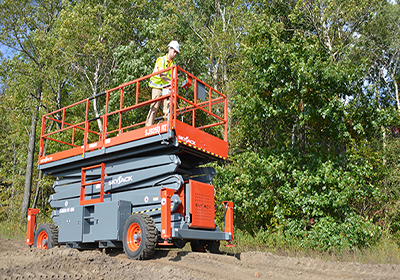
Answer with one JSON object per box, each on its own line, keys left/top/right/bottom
{"left": 39, "top": 66, "right": 228, "bottom": 166}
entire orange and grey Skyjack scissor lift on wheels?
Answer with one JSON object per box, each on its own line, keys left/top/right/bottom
{"left": 27, "top": 66, "right": 233, "bottom": 259}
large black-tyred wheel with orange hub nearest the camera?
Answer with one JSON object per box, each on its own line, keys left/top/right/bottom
{"left": 122, "top": 214, "right": 157, "bottom": 260}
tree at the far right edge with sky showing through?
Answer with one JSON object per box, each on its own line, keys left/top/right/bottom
{"left": 354, "top": 2, "right": 400, "bottom": 240}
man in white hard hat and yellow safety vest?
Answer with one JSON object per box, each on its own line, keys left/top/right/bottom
{"left": 146, "top": 41, "right": 179, "bottom": 126}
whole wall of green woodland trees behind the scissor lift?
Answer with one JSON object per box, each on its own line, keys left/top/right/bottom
{"left": 0, "top": 0, "right": 400, "bottom": 250}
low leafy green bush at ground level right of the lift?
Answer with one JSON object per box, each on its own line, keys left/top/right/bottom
{"left": 214, "top": 152, "right": 381, "bottom": 251}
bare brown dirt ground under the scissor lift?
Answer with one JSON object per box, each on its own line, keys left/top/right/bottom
{"left": 0, "top": 239, "right": 400, "bottom": 280}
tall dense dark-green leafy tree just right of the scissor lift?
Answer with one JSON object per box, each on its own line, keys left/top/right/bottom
{"left": 217, "top": 1, "right": 388, "bottom": 250}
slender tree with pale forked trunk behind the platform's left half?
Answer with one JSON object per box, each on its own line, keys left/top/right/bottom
{"left": 55, "top": 0, "right": 145, "bottom": 131}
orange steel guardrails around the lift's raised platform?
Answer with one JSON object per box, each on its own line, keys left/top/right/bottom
{"left": 39, "top": 65, "right": 228, "bottom": 165}
